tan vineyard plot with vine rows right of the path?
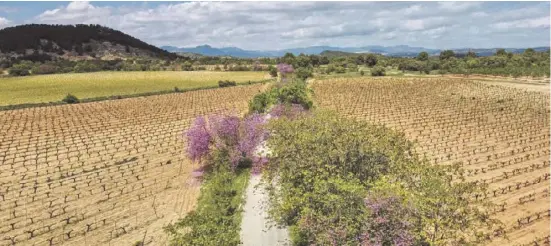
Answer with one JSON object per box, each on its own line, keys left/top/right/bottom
{"left": 313, "top": 78, "right": 550, "bottom": 245}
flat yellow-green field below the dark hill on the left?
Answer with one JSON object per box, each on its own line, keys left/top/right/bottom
{"left": 0, "top": 71, "right": 269, "bottom": 106}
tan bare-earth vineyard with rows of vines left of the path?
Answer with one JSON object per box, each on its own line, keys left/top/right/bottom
{"left": 0, "top": 85, "right": 262, "bottom": 245}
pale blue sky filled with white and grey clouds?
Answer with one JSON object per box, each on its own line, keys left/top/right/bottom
{"left": 0, "top": 1, "right": 550, "bottom": 50}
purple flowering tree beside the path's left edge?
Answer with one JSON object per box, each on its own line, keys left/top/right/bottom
{"left": 184, "top": 114, "right": 267, "bottom": 172}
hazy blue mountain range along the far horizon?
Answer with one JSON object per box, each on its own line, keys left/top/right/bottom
{"left": 160, "top": 45, "right": 549, "bottom": 58}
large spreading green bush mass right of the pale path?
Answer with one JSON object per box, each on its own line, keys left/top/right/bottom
{"left": 264, "top": 112, "right": 495, "bottom": 245}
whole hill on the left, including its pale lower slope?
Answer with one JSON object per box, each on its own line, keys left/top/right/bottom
{"left": 0, "top": 24, "right": 177, "bottom": 61}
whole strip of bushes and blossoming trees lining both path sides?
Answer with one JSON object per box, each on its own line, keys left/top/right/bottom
{"left": 167, "top": 66, "right": 500, "bottom": 245}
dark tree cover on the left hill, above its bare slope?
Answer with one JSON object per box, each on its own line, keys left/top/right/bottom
{"left": 0, "top": 24, "right": 176, "bottom": 58}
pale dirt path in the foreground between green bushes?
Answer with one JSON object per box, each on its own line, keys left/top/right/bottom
{"left": 241, "top": 175, "right": 291, "bottom": 246}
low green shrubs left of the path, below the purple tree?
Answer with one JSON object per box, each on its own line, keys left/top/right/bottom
{"left": 164, "top": 153, "right": 250, "bottom": 245}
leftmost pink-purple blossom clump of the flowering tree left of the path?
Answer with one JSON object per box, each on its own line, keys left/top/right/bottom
{"left": 184, "top": 117, "right": 212, "bottom": 161}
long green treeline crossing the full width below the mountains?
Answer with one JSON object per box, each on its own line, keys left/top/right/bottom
{"left": 0, "top": 45, "right": 550, "bottom": 78}
